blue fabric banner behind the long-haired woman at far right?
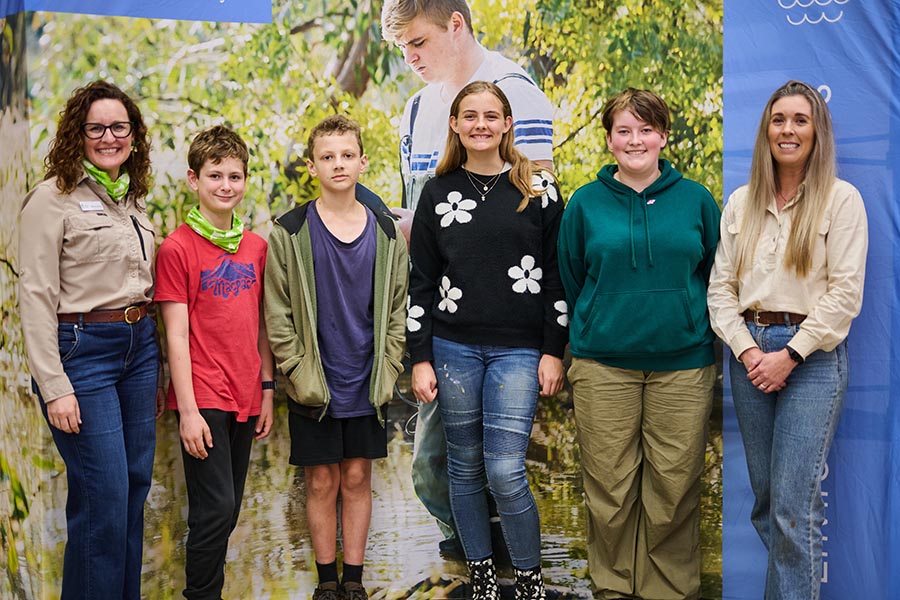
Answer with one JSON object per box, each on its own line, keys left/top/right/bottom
{"left": 722, "top": 0, "right": 900, "bottom": 600}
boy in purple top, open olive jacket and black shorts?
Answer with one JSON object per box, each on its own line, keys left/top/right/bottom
{"left": 265, "top": 115, "right": 408, "bottom": 600}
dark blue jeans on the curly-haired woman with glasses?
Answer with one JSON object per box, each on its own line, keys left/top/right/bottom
{"left": 41, "top": 318, "right": 159, "bottom": 600}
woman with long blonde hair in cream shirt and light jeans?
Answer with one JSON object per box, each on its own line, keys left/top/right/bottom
{"left": 708, "top": 81, "right": 868, "bottom": 600}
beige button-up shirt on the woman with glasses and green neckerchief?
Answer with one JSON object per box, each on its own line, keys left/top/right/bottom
{"left": 19, "top": 176, "right": 155, "bottom": 402}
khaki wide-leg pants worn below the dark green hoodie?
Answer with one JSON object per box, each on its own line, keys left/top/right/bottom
{"left": 568, "top": 358, "right": 715, "bottom": 600}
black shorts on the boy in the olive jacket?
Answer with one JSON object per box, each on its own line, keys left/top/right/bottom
{"left": 288, "top": 412, "right": 387, "bottom": 467}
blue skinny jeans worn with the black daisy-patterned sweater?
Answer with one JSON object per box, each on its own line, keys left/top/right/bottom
{"left": 432, "top": 337, "right": 541, "bottom": 569}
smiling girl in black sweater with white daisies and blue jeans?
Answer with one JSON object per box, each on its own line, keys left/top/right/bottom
{"left": 407, "top": 81, "right": 567, "bottom": 600}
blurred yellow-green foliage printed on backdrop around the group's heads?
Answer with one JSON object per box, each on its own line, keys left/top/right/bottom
{"left": 29, "top": 0, "right": 722, "bottom": 233}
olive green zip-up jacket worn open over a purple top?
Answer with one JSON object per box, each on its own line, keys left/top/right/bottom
{"left": 265, "top": 197, "right": 409, "bottom": 425}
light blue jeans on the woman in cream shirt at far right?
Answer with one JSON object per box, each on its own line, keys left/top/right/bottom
{"left": 730, "top": 323, "right": 848, "bottom": 600}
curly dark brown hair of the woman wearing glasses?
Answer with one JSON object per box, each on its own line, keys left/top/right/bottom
{"left": 44, "top": 80, "right": 150, "bottom": 198}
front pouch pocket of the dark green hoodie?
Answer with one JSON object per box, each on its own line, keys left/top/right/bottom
{"left": 581, "top": 288, "right": 699, "bottom": 356}
